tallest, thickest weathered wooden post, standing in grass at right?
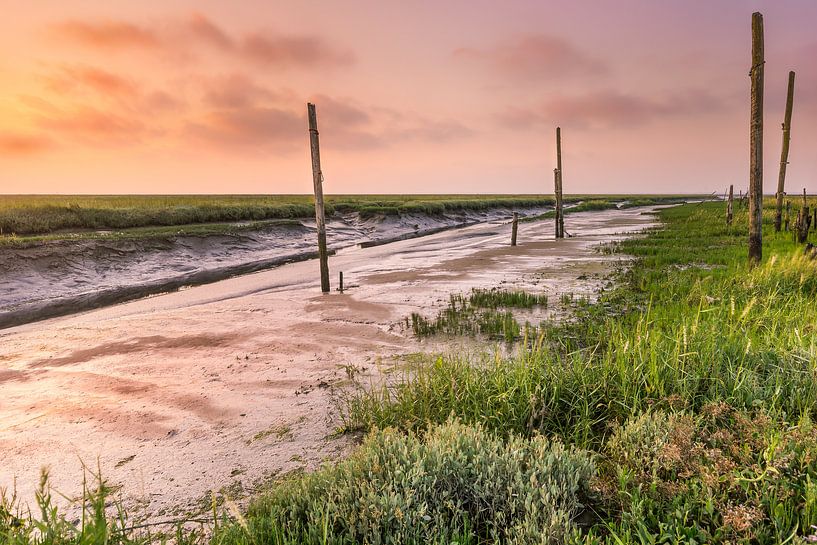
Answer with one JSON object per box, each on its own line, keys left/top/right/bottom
{"left": 749, "top": 12, "right": 765, "bottom": 264}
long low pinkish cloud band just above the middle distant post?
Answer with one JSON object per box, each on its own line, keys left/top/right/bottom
{"left": 499, "top": 90, "right": 726, "bottom": 128}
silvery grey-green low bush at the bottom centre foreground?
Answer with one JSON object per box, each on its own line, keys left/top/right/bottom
{"left": 222, "top": 421, "right": 594, "bottom": 545}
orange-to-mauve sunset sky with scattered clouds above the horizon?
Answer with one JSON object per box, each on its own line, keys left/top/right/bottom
{"left": 0, "top": 0, "right": 817, "bottom": 194}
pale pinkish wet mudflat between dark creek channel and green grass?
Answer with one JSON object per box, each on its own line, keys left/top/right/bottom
{"left": 0, "top": 209, "right": 654, "bottom": 516}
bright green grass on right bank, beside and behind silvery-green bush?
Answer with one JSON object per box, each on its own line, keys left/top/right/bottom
{"left": 346, "top": 198, "right": 817, "bottom": 544}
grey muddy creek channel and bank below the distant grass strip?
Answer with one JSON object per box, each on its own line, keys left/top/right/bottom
{"left": 0, "top": 208, "right": 546, "bottom": 328}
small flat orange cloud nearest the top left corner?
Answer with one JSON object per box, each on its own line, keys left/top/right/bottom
{"left": 52, "top": 20, "right": 160, "bottom": 49}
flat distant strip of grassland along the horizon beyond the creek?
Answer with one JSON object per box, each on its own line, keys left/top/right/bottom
{"left": 0, "top": 195, "right": 700, "bottom": 243}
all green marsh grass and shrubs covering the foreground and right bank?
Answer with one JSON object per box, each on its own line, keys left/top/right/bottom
{"left": 6, "top": 197, "right": 817, "bottom": 545}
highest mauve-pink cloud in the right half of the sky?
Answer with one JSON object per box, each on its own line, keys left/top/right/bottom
{"left": 454, "top": 34, "right": 609, "bottom": 81}
